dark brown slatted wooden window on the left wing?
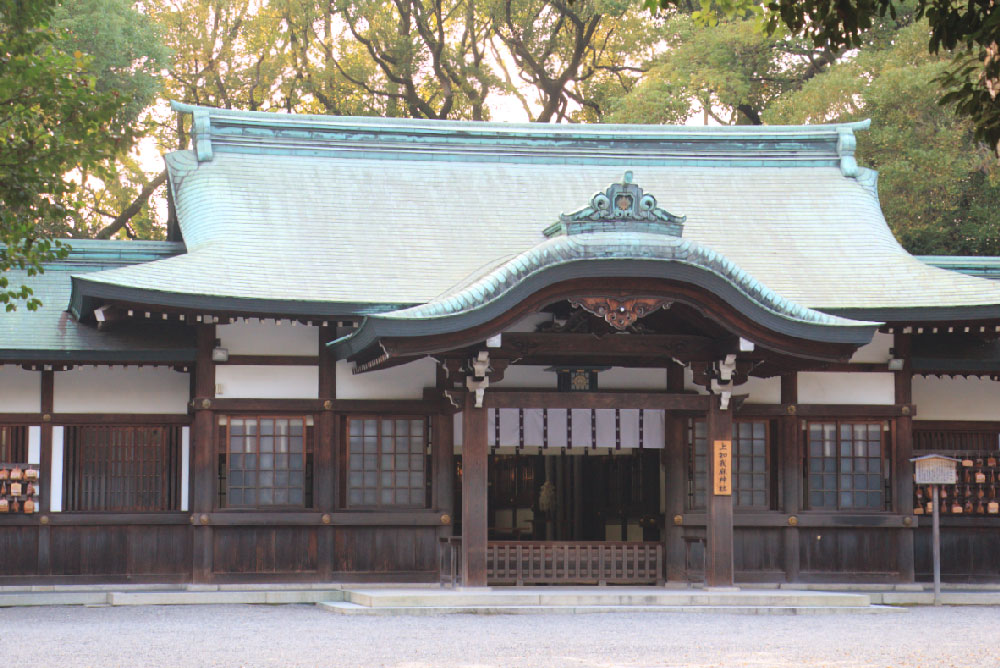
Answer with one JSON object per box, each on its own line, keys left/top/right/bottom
{"left": 63, "top": 426, "right": 181, "bottom": 512}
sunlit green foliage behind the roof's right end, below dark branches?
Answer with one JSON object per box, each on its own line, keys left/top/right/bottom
{"left": 764, "top": 22, "right": 1000, "bottom": 255}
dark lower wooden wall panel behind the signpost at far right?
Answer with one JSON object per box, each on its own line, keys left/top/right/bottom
{"left": 914, "top": 526, "right": 1000, "bottom": 582}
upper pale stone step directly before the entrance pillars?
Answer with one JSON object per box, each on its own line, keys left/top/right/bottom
{"left": 344, "top": 587, "right": 871, "bottom": 608}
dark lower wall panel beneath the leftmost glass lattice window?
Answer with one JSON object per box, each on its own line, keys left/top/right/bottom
{"left": 212, "top": 527, "right": 319, "bottom": 574}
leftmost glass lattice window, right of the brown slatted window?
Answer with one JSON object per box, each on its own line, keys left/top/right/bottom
{"left": 219, "top": 416, "right": 312, "bottom": 508}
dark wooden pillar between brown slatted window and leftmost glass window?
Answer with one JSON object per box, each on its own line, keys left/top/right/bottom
{"left": 190, "top": 324, "right": 218, "bottom": 582}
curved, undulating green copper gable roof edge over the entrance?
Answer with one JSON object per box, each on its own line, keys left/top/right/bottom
{"left": 332, "top": 232, "right": 881, "bottom": 357}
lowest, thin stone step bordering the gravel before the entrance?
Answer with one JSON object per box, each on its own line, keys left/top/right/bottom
{"left": 317, "top": 602, "right": 906, "bottom": 617}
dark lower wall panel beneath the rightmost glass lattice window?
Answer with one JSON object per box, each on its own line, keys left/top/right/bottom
{"left": 799, "top": 529, "right": 899, "bottom": 574}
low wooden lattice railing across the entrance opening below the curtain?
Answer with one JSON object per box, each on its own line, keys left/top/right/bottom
{"left": 486, "top": 541, "right": 663, "bottom": 585}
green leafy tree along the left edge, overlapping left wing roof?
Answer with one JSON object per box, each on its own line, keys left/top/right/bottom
{"left": 0, "top": 0, "right": 132, "bottom": 311}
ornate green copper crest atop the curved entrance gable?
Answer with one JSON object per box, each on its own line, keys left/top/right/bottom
{"left": 544, "top": 171, "right": 687, "bottom": 237}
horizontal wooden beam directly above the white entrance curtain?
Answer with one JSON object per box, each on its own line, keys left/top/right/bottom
{"left": 483, "top": 390, "right": 711, "bottom": 411}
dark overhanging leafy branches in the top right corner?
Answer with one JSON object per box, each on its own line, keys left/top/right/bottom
{"left": 644, "top": 0, "right": 1000, "bottom": 152}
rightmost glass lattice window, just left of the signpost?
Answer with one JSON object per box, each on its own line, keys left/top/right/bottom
{"left": 806, "top": 421, "right": 887, "bottom": 510}
